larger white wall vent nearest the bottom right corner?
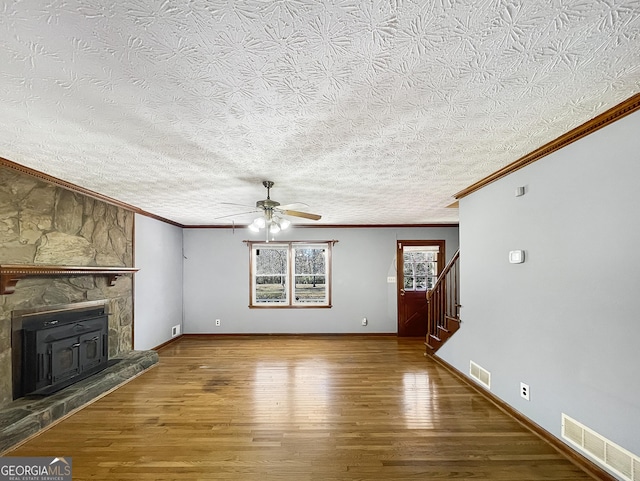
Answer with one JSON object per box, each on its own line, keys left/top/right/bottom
{"left": 562, "top": 413, "right": 640, "bottom": 481}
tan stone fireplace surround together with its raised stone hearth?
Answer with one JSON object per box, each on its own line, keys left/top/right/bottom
{"left": 0, "top": 163, "right": 157, "bottom": 452}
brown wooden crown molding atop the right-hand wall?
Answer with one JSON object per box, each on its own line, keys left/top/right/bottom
{"left": 454, "top": 93, "right": 640, "bottom": 199}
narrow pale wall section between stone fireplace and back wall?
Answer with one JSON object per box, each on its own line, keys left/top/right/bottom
{"left": 133, "top": 214, "right": 182, "bottom": 349}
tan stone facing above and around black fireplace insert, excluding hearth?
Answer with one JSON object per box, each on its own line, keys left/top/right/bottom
{"left": 0, "top": 162, "right": 134, "bottom": 408}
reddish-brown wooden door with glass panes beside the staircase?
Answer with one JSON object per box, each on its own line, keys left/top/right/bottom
{"left": 396, "top": 240, "right": 444, "bottom": 337}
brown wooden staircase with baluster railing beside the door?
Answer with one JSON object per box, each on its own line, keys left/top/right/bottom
{"left": 425, "top": 249, "right": 460, "bottom": 355}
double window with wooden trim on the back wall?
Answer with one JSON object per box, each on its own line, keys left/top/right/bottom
{"left": 249, "top": 241, "right": 333, "bottom": 307}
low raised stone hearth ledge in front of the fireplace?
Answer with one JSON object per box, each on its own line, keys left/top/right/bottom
{"left": 0, "top": 351, "right": 158, "bottom": 455}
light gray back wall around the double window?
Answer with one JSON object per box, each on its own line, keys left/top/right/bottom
{"left": 184, "top": 226, "right": 458, "bottom": 334}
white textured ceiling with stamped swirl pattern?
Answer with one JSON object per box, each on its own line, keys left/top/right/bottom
{"left": 0, "top": 0, "right": 640, "bottom": 225}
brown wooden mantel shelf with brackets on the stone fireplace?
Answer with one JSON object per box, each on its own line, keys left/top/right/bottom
{"left": 0, "top": 264, "right": 138, "bottom": 295}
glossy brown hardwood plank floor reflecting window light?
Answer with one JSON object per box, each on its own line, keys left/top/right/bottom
{"left": 5, "top": 336, "right": 592, "bottom": 481}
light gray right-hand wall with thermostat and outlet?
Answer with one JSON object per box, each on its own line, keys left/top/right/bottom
{"left": 439, "top": 109, "right": 640, "bottom": 464}
